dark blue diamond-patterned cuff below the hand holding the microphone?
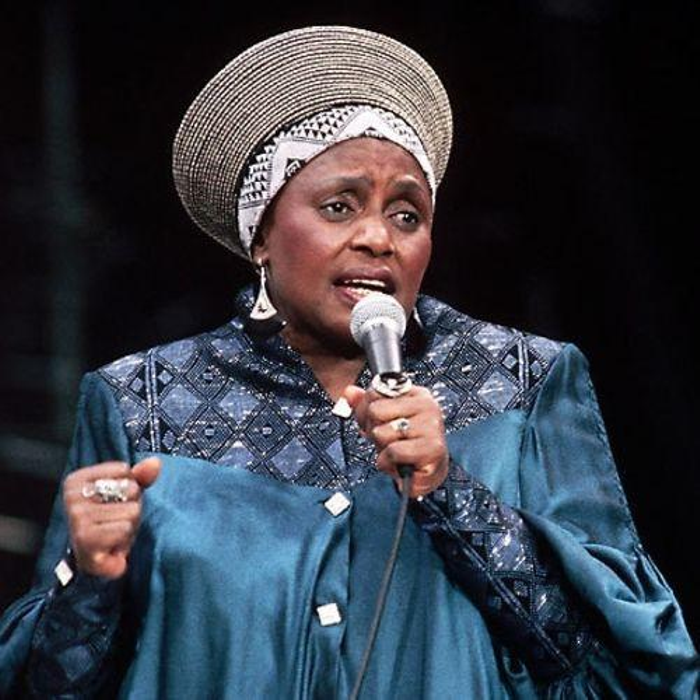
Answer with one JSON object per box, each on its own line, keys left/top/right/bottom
{"left": 411, "top": 465, "right": 593, "bottom": 675}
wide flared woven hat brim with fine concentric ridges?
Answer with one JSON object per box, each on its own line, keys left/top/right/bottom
{"left": 173, "top": 26, "right": 452, "bottom": 257}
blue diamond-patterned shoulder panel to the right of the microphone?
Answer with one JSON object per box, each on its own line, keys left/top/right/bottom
{"left": 417, "top": 296, "right": 569, "bottom": 420}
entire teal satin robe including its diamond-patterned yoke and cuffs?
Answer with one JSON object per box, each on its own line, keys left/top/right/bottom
{"left": 0, "top": 298, "right": 698, "bottom": 698}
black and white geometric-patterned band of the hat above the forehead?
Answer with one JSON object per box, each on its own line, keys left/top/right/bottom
{"left": 237, "top": 105, "right": 436, "bottom": 256}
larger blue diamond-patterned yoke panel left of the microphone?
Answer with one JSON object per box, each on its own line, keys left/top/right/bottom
{"left": 99, "top": 312, "right": 375, "bottom": 488}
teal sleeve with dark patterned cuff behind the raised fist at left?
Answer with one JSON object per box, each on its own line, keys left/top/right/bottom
{"left": 0, "top": 374, "right": 131, "bottom": 697}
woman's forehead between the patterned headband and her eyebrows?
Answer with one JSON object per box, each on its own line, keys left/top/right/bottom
{"left": 288, "top": 137, "right": 430, "bottom": 191}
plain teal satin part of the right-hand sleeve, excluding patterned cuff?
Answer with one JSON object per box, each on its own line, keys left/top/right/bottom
{"left": 520, "top": 345, "right": 698, "bottom": 698}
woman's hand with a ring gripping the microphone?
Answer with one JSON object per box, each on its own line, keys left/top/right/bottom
{"left": 343, "top": 386, "right": 449, "bottom": 498}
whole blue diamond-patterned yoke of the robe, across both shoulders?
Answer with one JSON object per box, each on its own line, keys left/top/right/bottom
{"left": 99, "top": 289, "right": 561, "bottom": 489}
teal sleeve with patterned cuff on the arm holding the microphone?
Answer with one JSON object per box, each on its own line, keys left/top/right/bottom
{"left": 412, "top": 345, "right": 698, "bottom": 699}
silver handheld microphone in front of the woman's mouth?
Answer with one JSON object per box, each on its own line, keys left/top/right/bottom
{"left": 350, "top": 292, "right": 411, "bottom": 397}
